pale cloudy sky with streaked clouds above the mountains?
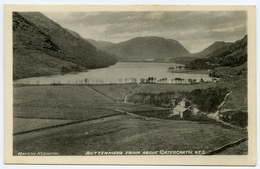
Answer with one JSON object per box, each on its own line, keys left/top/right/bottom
{"left": 42, "top": 11, "right": 247, "bottom": 53}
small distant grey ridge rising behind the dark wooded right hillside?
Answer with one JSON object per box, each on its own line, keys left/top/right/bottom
{"left": 193, "top": 41, "right": 232, "bottom": 57}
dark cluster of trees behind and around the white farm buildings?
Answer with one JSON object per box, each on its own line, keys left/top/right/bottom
{"left": 127, "top": 87, "right": 227, "bottom": 112}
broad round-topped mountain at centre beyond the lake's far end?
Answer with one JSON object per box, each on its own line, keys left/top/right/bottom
{"left": 102, "top": 36, "right": 191, "bottom": 60}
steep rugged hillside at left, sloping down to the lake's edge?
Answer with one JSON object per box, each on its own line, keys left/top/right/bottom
{"left": 13, "top": 12, "right": 117, "bottom": 79}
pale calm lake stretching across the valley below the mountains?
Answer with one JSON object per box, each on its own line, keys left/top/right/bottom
{"left": 14, "top": 62, "right": 211, "bottom": 84}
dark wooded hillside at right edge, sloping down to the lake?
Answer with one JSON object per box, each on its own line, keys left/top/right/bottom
{"left": 186, "top": 35, "right": 247, "bottom": 69}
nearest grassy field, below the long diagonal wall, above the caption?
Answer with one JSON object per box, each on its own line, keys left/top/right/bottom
{"left": 13, "top": 115, "right": 245, "bottom": 155}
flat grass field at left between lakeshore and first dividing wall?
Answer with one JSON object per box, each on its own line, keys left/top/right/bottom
{"left": 13, "top": 85, "right": 116, "bottom": 120}
